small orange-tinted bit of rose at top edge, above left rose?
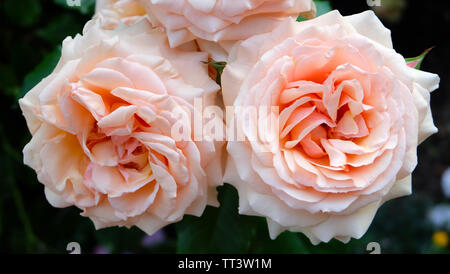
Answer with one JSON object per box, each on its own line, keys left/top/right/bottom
{"left": 91, "top": 0, "right": 146, "bottom": 30}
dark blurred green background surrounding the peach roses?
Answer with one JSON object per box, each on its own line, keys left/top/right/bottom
{"left": 0, "top": 0, "right": 450, "bottom": 253}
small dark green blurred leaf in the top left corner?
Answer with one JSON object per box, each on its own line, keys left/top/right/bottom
{"left": 3, "top": 0, "right": 42, "bottom": 27}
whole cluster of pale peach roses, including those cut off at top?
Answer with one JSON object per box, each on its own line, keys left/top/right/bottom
{"left": 20, "top": 0, "right": 439, "bottom": 243}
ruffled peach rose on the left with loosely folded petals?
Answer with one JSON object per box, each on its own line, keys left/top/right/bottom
{"left": 20, "top": 19, "right": 222, "bottom": 234}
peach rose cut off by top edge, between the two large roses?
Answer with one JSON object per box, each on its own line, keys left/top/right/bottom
{"left": 139, "top": 0, "right": 315, "bottom": 61}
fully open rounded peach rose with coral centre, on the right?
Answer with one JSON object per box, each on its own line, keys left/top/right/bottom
{"left": 222, "top": 11, "right": 439, "bottom": 244}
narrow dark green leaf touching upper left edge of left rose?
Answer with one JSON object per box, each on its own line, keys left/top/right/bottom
{"left": 19, "top": 47, "right": 61, "bottom": 97}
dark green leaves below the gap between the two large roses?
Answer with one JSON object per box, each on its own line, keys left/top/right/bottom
{"left": 176, "top": 184, "right": 309, "bottom": 254}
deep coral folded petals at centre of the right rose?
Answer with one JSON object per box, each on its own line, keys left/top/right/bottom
{"left": 280, "top": 75, "right": 372, "bottom": 165}
